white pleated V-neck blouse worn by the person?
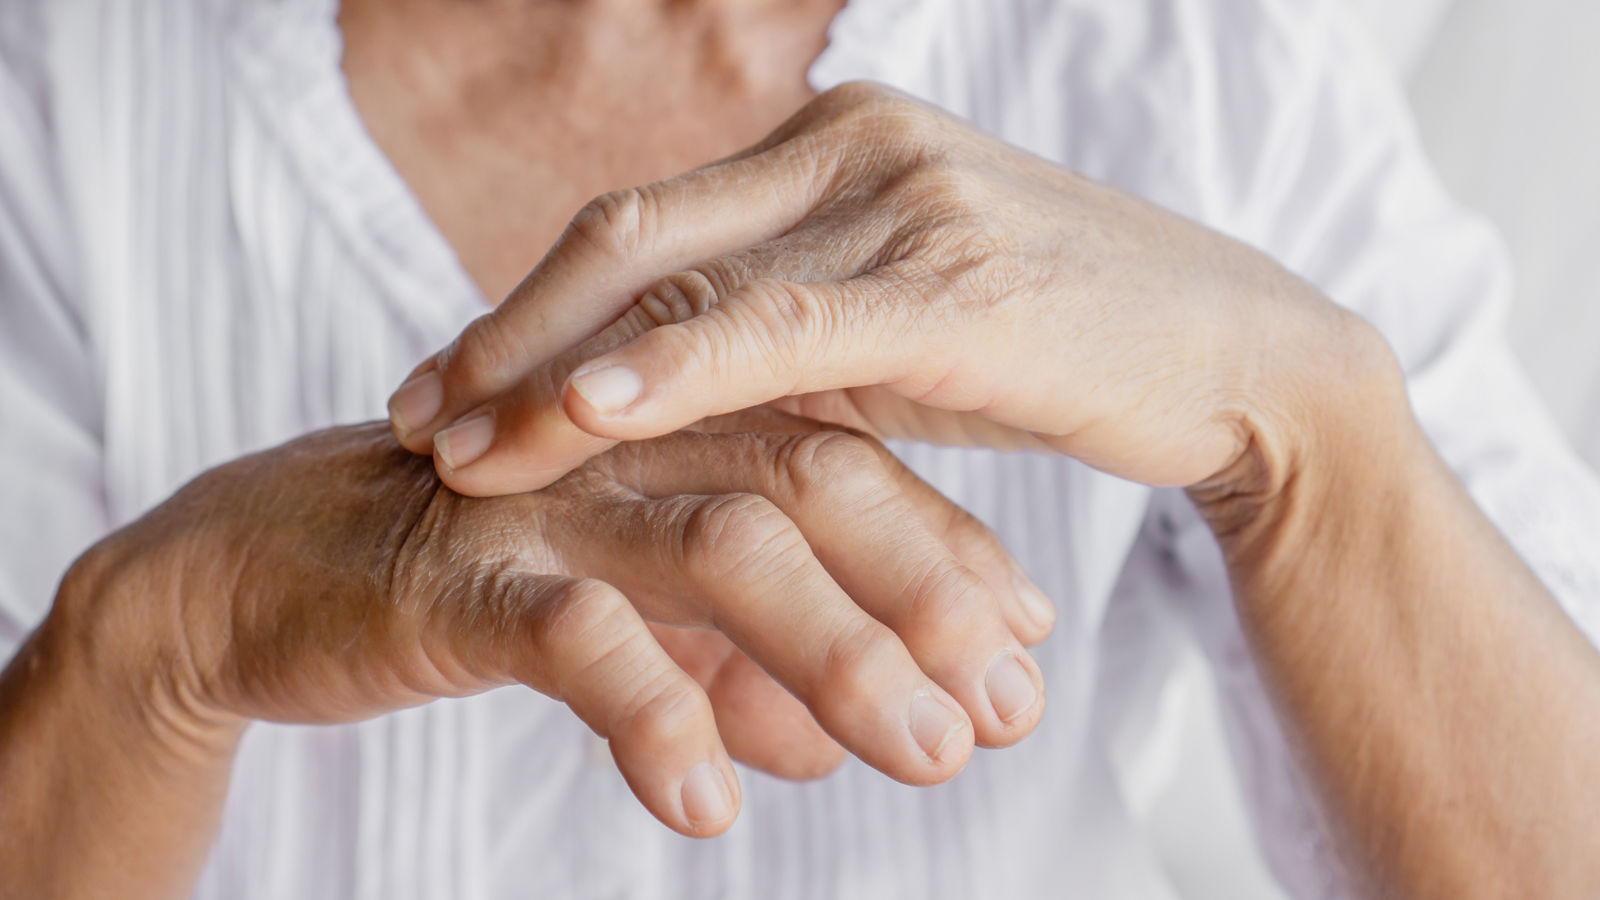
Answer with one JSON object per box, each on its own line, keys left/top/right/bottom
{"left": 0, "top": 0, "right": 1600, "bottom": 900}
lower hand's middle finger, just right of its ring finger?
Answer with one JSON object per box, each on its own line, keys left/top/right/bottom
{"left": 606, "top": 431, "right": 1043, "bottom": 746}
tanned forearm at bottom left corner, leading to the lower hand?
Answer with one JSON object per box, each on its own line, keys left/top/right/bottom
{"left": 0, "top": 550, "right": 240, "bottom": 898}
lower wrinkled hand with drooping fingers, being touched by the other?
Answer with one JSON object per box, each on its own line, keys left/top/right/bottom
{"left": 62, "top": 413, "right": 1048, "bottom": 836}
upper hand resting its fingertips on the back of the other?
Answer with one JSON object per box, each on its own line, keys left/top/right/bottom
{"left": 380, "top": 85, "right": 1350, "bottom": 495}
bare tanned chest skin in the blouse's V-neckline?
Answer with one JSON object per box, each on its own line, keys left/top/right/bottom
{"left": 339, "top": 0, "right": 842, "bottom": 301}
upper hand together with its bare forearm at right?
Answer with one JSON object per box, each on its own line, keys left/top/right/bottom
{"left": 400, "top": 83, "right": 1600, "bottom": 897}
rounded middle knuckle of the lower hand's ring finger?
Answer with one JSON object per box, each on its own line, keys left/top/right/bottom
{"left": 682, "top": 493, "right": 805, "bottom": 578}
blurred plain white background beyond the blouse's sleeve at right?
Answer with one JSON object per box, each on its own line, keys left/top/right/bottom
{"left": 1133, "top": 0, "right": 1600, "bottom": 900}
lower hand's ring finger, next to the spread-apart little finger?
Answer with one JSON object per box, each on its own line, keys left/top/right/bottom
{"left": 562, "top": 493, "right": 973, "bottom": 785}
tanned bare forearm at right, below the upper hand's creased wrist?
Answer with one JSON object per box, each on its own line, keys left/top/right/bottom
{"left": 1195, "top": 325, "right": 1600, "bottom": 897}
